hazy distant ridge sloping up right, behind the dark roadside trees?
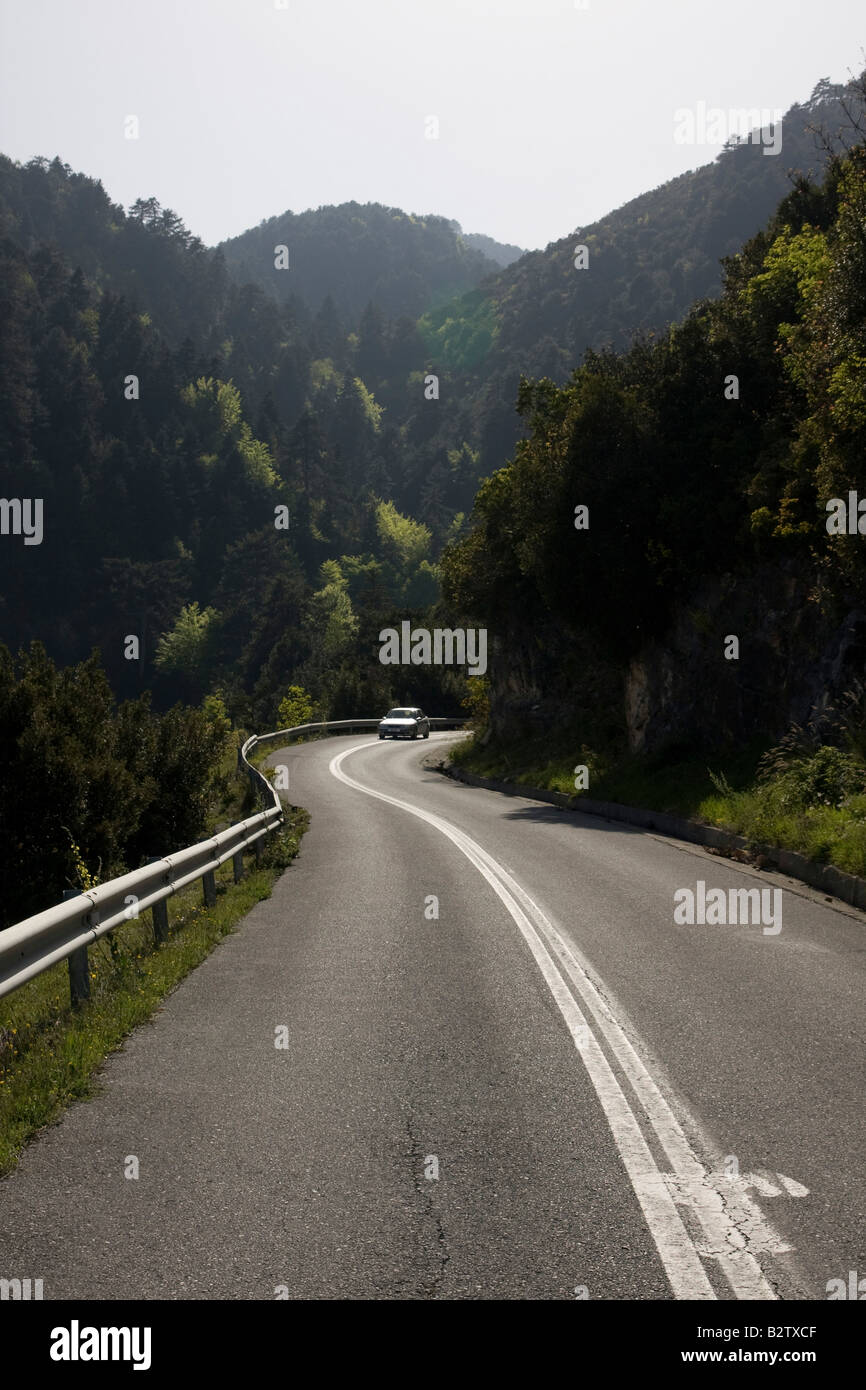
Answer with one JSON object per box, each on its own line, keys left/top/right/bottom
{"left": 408, "top": 81, "right": 856, "bottom": 486}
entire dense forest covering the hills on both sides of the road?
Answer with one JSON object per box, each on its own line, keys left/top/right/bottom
{"left": 0, "top": 83, "right": 866, "bottom": 922}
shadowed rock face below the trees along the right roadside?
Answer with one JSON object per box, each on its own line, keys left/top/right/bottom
{"left": 488, "top": 563, "right": 866, "bottom": 753}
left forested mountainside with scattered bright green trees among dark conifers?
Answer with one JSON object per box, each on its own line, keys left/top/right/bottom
{"left": 0, "top": 160, "right": 489, "bottom": 724}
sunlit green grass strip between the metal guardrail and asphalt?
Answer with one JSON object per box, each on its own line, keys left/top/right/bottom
{"left": 0, "top": 806, "right": 309, "bottom": 1175}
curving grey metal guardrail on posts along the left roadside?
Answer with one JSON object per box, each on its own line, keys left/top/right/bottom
{"left": 0, "top": 719, "right": 466, "bottom": 1005}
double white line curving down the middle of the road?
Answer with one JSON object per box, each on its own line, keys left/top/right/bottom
{"left": 329, "top": 742, "right": 791, "bottom": 1298}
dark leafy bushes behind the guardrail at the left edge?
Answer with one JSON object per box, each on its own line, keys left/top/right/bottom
{"left": 0, "top": 642, "right": 228, "bottom": 927}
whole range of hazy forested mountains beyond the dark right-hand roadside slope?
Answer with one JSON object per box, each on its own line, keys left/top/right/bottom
{"left": 0, "top": 76, "right": 861, "bottom": 756}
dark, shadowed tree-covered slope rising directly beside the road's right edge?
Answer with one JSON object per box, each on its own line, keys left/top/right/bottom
{"left": 442, "top": 127, "right": 866, "bottom": 755}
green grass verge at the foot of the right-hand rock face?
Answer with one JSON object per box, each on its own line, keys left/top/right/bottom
{"left": 450, "top": 735, "right": 866, "bottom": 876}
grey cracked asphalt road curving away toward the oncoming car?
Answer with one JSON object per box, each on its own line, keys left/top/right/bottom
{"left": 0, "top": 734, "right": 866, "bottom": 1300}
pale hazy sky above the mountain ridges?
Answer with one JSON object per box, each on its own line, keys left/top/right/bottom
{"left": 0, "top": 0, "right": 866, "bottom": 247}
